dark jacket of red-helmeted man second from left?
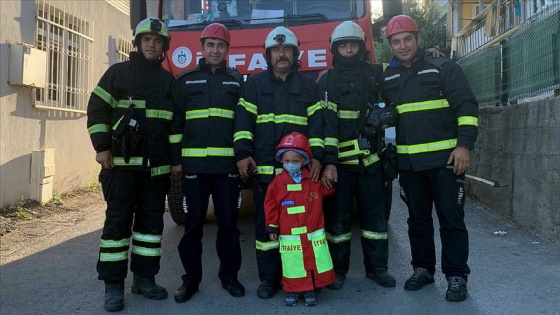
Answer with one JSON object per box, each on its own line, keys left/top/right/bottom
{"left": 172, "top": 59, "right": 242, "bottom": 174}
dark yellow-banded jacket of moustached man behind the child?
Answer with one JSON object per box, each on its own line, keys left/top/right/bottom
{"left": 234, "top": 70, "right": 324, "bottom": 183}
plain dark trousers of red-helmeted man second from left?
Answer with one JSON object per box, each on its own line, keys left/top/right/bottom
{"left": 178, "top": 174, "right": 241, "bottom": 285}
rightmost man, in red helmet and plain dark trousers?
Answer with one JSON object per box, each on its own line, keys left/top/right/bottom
{"left": 382, "top": 15, "right": 478, "bottom": 301}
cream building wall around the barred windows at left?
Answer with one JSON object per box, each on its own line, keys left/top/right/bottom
{"left": 0, "top": 0, "right": 132, "bottom": 207}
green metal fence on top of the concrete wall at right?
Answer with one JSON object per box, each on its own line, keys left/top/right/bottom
{"left": 459, "top": 11, "right": 560, "bottom": 103}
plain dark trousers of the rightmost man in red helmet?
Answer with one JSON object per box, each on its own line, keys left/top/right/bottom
{"left": 399, "top": 165, "right": 470, "bottom": 278}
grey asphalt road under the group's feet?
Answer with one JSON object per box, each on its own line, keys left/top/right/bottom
{"left": 0, "top": 183, "right": 560, "bottom": 315}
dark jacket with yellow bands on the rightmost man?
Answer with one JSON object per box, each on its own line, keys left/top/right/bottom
{"left": 382, "top": 51, "right": 478, "bottom": 171}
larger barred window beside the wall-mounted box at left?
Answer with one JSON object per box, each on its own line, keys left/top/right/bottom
{"left": 35, "top": 2, "right": 94, "bottom": 113}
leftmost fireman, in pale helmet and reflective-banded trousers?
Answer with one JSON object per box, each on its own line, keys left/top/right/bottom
{"left": 87, "top": 18, "right": 174, "bottom": 311}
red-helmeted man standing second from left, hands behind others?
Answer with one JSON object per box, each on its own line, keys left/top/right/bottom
{"left": 172, "top": 23, "right": 245, "bottom": 303}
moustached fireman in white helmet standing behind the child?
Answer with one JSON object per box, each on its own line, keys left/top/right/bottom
{"left": 234, "top": 26, "right": 323, "bottom": 299}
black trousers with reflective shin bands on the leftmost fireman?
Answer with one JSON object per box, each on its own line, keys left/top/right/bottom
{"left": 97, "top": 169, "right": 170, "bottom": 281}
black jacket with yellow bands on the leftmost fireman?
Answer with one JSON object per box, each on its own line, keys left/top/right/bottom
{"left": 87, "top": 52, "right": 173, "bottom": 176}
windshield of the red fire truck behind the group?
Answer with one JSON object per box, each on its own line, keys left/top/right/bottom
{"left": 160, "top": 0, "right": 367, "bottom": 29}
